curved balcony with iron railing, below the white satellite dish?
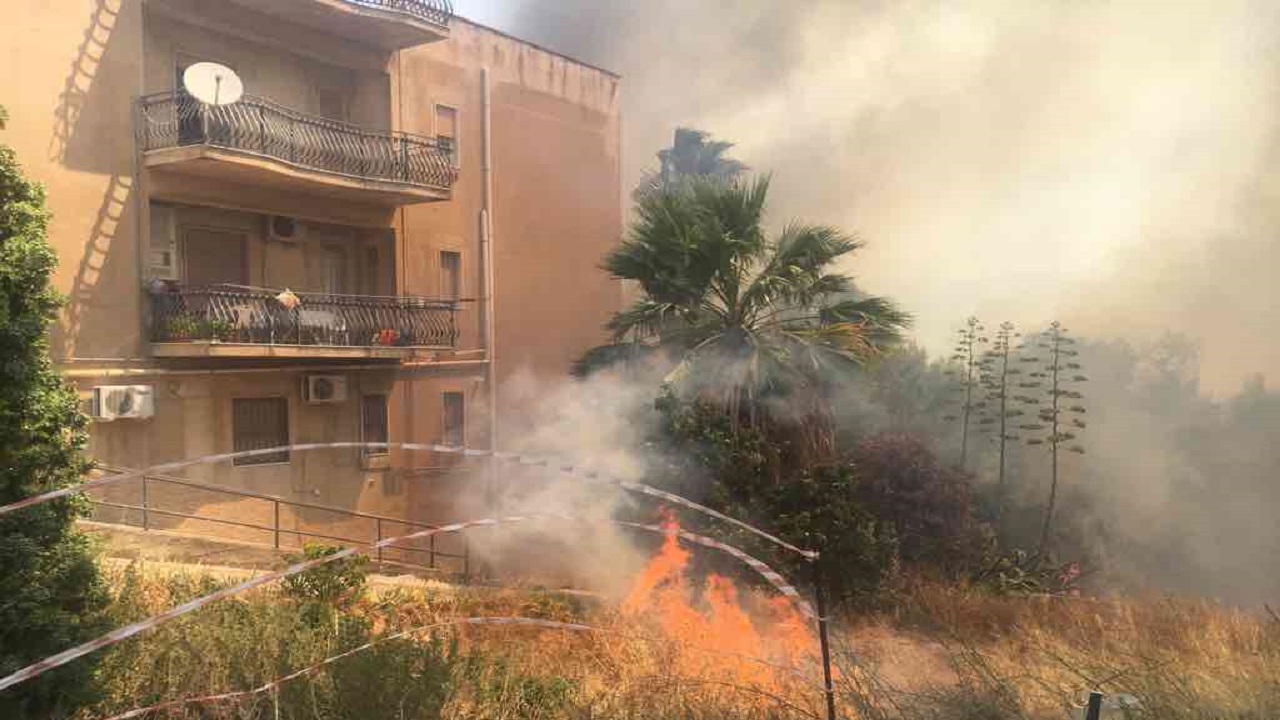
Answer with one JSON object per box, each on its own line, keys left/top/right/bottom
{"left": 138, "top": 92, "right": 458, "bottom": 206}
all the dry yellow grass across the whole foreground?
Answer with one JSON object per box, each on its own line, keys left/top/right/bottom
{"left": 80, "top": 568, "right": 1280, "bottom": 720}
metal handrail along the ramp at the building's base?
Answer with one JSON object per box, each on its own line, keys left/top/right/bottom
{"left": 88, "top": 466, "right": 471, "bottom": 578}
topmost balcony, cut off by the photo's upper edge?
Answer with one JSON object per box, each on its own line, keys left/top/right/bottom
{"left": 227, "top": 0, "right": 453, "bottom": 50}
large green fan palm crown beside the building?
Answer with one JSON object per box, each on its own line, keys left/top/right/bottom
{"left": 577, "top": 177, "right": 910, "bottom": 456}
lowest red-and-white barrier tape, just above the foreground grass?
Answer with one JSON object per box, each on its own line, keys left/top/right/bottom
{"left": 102, "top": 609, "right": 808, "bottom": 720}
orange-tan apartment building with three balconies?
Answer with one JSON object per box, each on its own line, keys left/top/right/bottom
{"left": 0, "top": 0, "right": 622, "bottom": 538}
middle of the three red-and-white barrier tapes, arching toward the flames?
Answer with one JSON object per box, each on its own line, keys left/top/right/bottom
{"left": 0, "top": 515, "right": 815, "bottom": 691}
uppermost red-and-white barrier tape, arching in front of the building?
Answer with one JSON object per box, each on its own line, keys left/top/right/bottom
{"left": 0, "top": 442, "right": 818, "bottom": 560}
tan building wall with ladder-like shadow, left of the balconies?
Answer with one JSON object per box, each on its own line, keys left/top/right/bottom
{"left": 0, "top": 0, "right": 143, "bottom": 357}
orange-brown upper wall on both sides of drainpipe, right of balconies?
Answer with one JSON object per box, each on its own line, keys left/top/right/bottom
{"left": 393, "top": 20, "right": 622, "bottom": 380}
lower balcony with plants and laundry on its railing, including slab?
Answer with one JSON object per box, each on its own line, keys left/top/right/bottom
{"left": 151, "top": 283, "right": 458, "bottom": 359}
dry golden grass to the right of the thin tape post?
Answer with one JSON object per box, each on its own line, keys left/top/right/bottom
{"left": 829, "top": 584, "right": 1280, "bottom": 720}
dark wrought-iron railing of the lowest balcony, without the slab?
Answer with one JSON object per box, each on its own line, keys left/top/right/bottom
{"left": 151, "top": 283, "right": 460, "bottom": 348}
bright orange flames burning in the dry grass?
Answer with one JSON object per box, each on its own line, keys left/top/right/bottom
{"left": 622, "top": 515, "right": 815, "bottom": 689}
